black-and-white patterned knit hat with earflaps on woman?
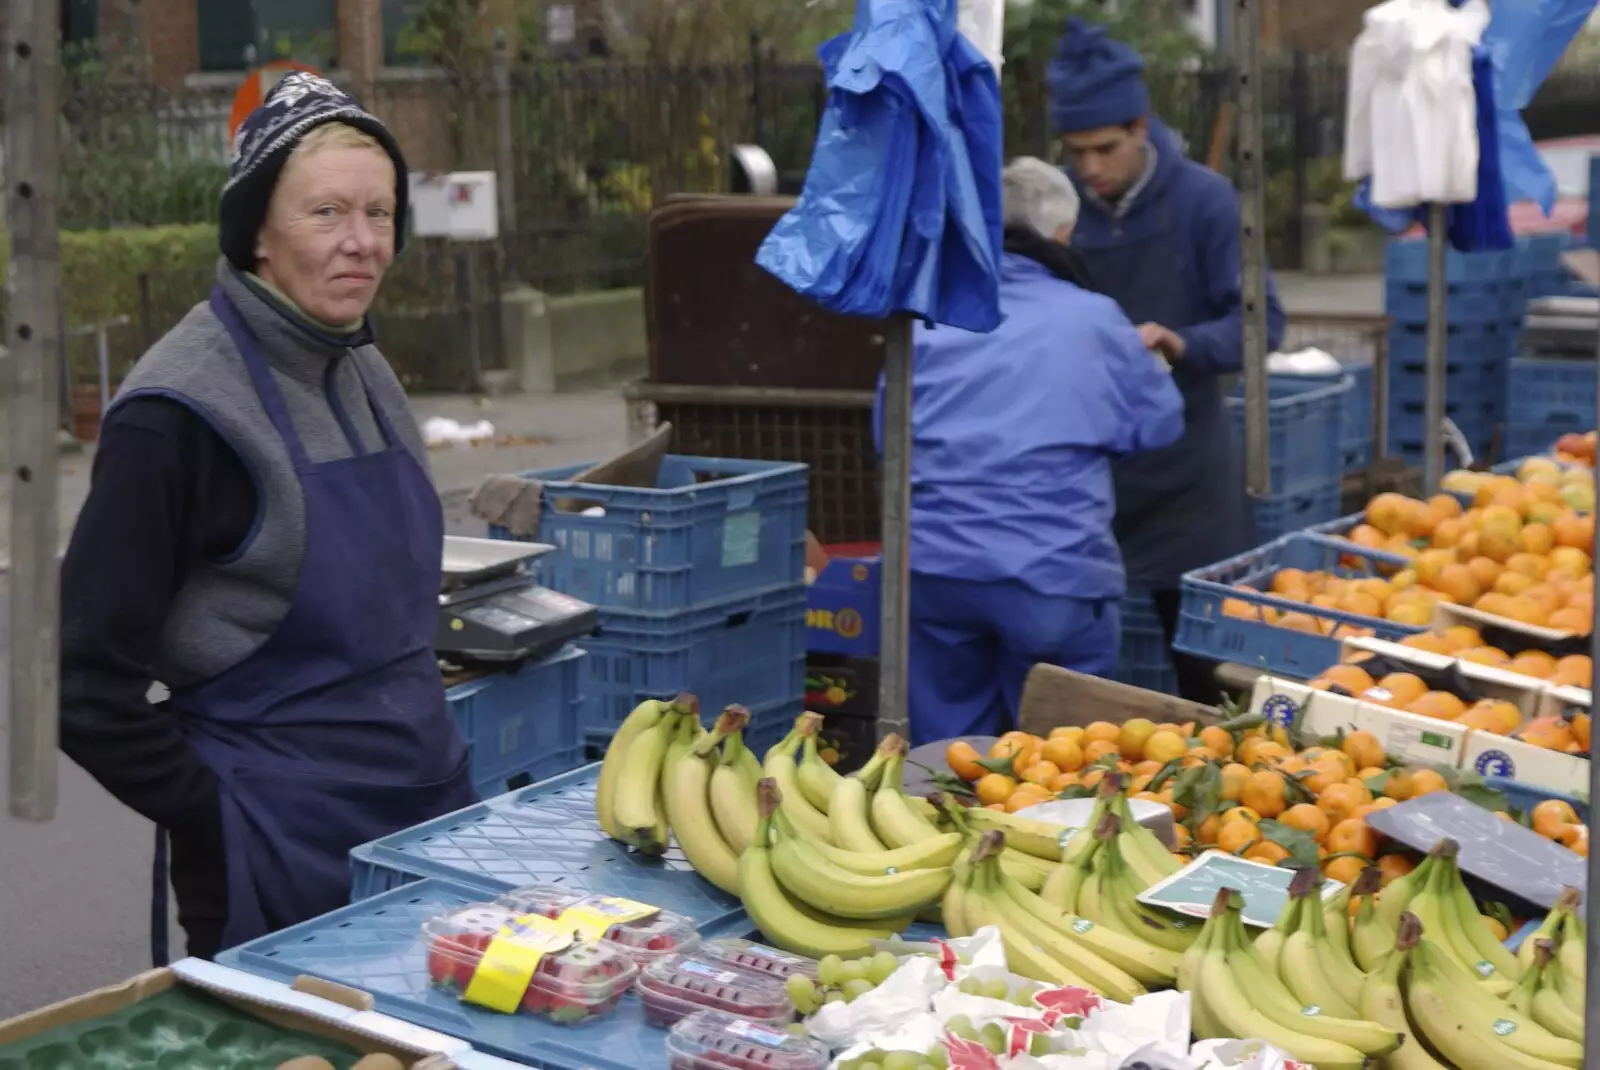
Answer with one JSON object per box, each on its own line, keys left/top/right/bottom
{"left": 218, "top": 70, "right": 410, "bottom": 272}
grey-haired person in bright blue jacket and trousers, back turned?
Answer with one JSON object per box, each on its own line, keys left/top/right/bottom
{"left": 877, "top": 158, "right": 1182, "bottom": 744}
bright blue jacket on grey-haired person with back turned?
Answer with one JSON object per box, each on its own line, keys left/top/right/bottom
{"left": 874, "top": 253, "right": 1182, "bottom": 598}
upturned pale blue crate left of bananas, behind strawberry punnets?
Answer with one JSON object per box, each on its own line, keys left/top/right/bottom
{"left": 350, "top": 765, "right": 736, "bottom": 916}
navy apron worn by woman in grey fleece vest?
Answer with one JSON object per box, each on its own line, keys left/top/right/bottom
{"left": 156, "top": 288, "right": 478, "bottom": 947}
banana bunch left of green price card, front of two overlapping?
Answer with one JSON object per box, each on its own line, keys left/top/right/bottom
{"left": 1042, "top": 812, "right": 1200, "bottom": 953}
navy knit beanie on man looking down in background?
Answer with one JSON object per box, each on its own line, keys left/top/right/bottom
{"left": 1045, "top": 18, "right": 1150, "bottom": 134}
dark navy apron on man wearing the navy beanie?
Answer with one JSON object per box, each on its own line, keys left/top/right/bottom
{"left": 1072, "top": 203, "right": 1254, "bottom": 590}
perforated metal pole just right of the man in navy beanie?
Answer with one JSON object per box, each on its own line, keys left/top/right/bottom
{"left": 1234, "top": 0, "right": 1272, "bottom": 497}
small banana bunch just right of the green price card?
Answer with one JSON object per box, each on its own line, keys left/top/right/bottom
{"left": 1261, "top": 868, "right": 1366, "bottom": 1019}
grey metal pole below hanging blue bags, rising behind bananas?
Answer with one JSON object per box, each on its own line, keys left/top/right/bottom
{"left": 878, "top": 317, "right": 912, "bottom": 739}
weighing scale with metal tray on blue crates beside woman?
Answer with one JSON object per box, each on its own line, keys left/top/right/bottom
{"left": 434, "top": 536, "right": 600, "bottom": 662}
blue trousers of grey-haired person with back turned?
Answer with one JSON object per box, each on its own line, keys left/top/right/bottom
{"left": 907, "top": 573, "right": 1118, "bottom": 745}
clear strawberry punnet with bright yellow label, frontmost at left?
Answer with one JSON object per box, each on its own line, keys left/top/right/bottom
{"left": 422, "top": 904, "right": 638, "bottom": 1024}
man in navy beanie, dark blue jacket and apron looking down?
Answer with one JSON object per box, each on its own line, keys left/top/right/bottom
{"left": 1048, "top": 19, "right": 1283, "bottom": 704}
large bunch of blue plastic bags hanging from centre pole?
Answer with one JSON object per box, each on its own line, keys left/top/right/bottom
{"left": 755, "top": 0, "right": 1002, "bottom": 331}
